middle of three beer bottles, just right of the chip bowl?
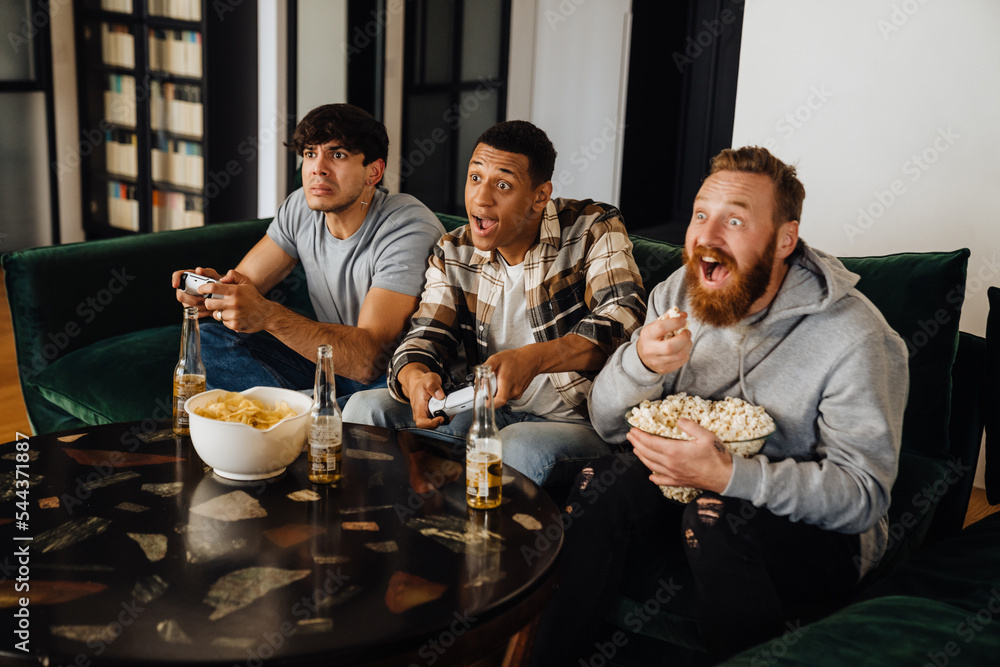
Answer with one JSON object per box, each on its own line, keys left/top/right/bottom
{"left": 308, "top": 345, "right": 344, "bottom": 484}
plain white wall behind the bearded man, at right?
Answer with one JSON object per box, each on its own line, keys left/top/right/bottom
{"left": 733, "top": 0, "right": 1000, "bottom": 490}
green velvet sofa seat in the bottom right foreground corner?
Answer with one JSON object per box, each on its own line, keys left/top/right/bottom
{"left": 724, "top": 514, "right": 1000, "bottom": 666}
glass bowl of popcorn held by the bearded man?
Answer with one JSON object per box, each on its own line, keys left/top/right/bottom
{"left": 625, "top": 392, "right": 775, "bottom": 503}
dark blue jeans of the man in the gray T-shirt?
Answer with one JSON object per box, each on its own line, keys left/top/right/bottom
{"left": 198, "top": 320, "right": 385, "bottom": 408}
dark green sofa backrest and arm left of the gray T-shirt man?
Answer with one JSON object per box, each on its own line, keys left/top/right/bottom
{"left": 2, "top": 220, "right": 268, "bottom": 384}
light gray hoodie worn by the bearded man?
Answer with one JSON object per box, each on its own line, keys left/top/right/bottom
{"left": 590, "top": 241, "right": 909, "bottom": 574}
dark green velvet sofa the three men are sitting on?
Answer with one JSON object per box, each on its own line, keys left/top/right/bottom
{"left": 2, "top": 215, "right": 1000, "bottom": 664}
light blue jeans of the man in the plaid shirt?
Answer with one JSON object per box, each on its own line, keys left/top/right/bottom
{"left": 344, "top": 389, "right": 615, "bottom": 485}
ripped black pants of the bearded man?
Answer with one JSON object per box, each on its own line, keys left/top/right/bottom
{"left": 531, "top": 454, "right": 860, "bottom": 665}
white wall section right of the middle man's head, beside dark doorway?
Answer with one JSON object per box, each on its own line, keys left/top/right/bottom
{"left": 524, "top": 0, "right": 632, "bottom": 204}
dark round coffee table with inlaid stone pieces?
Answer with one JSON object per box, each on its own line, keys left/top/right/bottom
{"left": 0, "top": 421, "right": 562, "bottom": 666}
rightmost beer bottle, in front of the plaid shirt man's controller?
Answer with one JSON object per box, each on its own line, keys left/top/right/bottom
{"left": 465, "top": 364, "right": 503, "bottom": 509}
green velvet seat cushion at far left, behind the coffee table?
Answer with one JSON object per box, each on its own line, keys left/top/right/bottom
{"left": 28, "top": 324, "right": 181, "bottom": 424}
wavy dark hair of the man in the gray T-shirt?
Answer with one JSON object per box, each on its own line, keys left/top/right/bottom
{"left": 286, "top": 104, "right": 389, "bottom": 166}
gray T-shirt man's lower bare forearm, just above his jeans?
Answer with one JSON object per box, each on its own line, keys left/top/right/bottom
{"left": 264, "top": 302, "right": 396, "bottom": 383}
